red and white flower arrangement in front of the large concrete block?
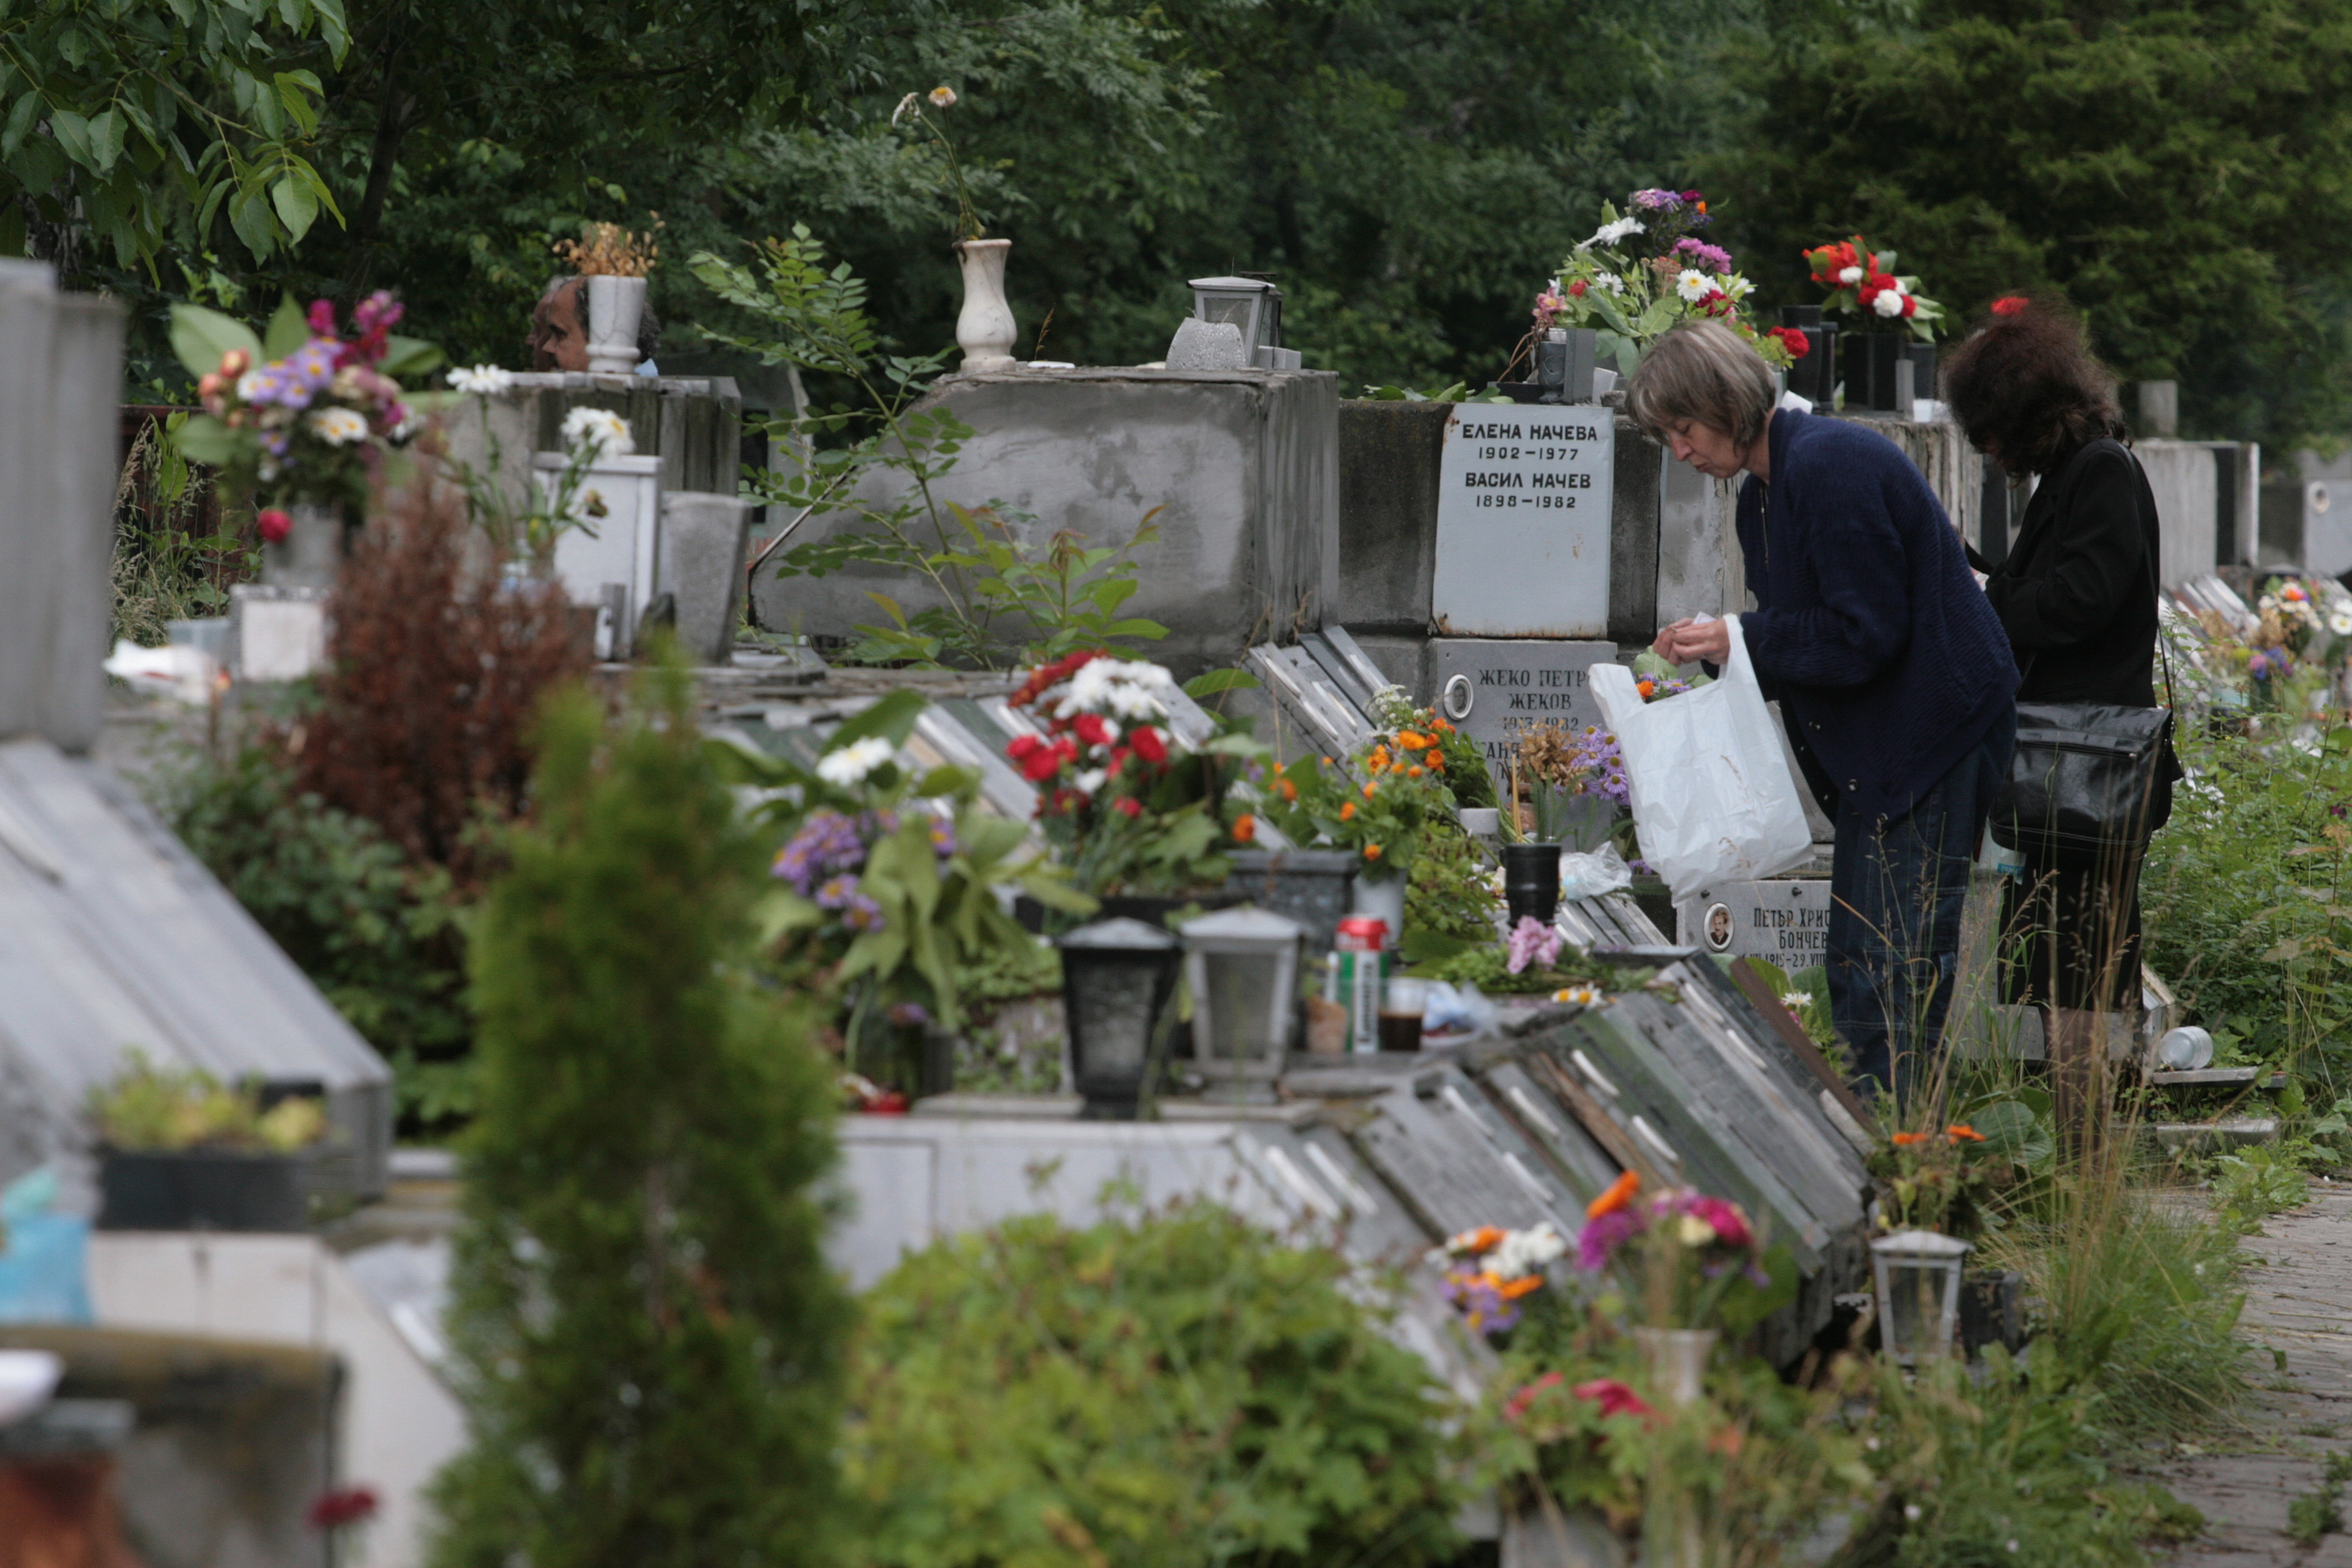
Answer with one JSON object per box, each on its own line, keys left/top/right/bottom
{"left": 1004, "top": 651, "right": 1265, "bottom": 893}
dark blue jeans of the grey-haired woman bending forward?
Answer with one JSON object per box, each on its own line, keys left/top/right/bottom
{"left": 1828, "top": 710, "right": 2018, "bottom": 1098}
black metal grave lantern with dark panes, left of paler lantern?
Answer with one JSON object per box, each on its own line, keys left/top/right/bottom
{"left": 1054, "top": 919, "right": 1183, "bottom": 1122}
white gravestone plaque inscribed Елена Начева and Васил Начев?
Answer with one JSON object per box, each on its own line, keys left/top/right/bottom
{"left": 1430, "top": 402, "right": 1616, "bottom": 637}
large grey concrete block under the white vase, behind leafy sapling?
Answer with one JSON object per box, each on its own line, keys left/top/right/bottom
{"left": 752, "top": 369, "right": 1340, "bottom": 677}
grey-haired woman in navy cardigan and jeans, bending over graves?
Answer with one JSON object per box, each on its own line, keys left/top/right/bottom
{"left": 1625, "top": 322, "right": 2018, "bottom": 1093}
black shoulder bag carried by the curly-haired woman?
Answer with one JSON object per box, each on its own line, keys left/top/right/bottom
{"left": 1992, "top": 442, "right": 2180, "bottom": 853}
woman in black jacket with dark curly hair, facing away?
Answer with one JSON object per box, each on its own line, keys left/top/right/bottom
{"left": 1943, "top": 299, "right": 2159, "bottom": 1140}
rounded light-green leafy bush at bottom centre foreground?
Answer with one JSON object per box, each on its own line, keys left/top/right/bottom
{"left": 844, "top": 1202, "right": 1456, "bottom": 1568}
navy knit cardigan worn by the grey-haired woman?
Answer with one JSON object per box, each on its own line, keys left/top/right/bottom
{"left": 1738, "top": 409, "right": 2018, "bottom": 823}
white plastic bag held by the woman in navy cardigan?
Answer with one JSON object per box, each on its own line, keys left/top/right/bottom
{"left": 1590, "top": 616, "right": 1814, "bottom": 903}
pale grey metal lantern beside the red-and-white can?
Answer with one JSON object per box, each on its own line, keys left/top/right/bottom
{"left": 1179, "top": 910, "right": 1306, "bottom": 1103}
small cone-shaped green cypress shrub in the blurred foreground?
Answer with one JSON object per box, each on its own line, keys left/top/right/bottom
{"left": 435, "top": 670, "right": 849, "bottom": 1568}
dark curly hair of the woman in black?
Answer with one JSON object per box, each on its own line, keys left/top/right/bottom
{"left": 1943, "top": 294, "right": 2124, "bottom": 477}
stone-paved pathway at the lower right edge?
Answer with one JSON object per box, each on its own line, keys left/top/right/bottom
{"left": 2157, "top": 1183, "right": 2352, "bottom": 1568}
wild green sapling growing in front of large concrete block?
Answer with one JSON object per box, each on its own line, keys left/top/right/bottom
{"left": 689, "top": 226, "right": 1167, "bottom": 670}
